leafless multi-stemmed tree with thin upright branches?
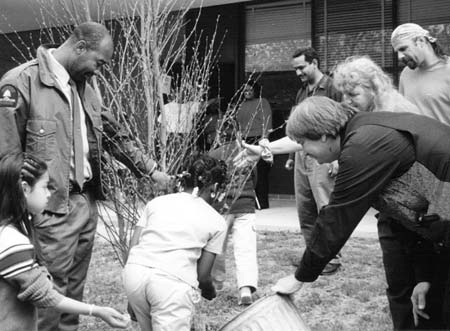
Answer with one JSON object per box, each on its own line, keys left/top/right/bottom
{"left": 3, "top": 0, "right": 262, "bottom": 270}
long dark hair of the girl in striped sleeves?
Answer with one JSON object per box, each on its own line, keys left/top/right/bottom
{"left": 0, "top": 153, "right": 47, "bottom": 229}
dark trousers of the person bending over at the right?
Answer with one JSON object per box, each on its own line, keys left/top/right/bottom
{"left": 378, "top": 216, "right": 450, "bottom": 330}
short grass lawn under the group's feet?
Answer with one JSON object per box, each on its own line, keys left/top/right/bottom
{"left": 80, "top": 232, "right": 392, "bottom": 331}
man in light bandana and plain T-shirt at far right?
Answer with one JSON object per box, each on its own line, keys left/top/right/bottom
{"left": 391, "top": 23, "right": 450, "bottom": 125}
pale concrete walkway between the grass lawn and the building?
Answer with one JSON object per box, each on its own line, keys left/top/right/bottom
{"left": 256, "top": 199, "right": 377, "bottom": 238}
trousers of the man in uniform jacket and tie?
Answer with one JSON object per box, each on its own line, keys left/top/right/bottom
{"left": 33, "top": 193, "right": 98, "bottom": 331}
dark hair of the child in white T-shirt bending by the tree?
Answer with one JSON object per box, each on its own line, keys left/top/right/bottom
{"left": 182, "top": 154, "right": 227, "bottom": 189}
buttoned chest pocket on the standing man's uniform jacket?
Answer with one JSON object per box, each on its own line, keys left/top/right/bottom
{"left": 26, "top": 120, "right": 56, "bottom": 161}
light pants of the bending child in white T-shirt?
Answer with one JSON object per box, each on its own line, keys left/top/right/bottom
{"left": 123, "top": 264, "right": 199, "bottom": 331}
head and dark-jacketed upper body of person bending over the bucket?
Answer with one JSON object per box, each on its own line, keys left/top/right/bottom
{"left": 287, "top": 97, "right": 450, "bottom": 282}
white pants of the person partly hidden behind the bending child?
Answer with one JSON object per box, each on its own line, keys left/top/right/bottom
{"left": 211, "top": 213, "right": 258, "bottom": 290}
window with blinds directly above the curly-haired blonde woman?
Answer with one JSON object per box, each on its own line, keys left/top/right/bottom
{"left": 313, "top": 0, "right": 393, "bottom": 72}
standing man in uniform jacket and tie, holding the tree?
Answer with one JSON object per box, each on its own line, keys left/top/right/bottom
{"left": 0, "top": 22, "right": 169, "bottom": 331}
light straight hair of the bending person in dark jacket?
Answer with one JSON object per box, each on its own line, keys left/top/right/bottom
{"left": 286, "top": 96, "right": 357, "bottom": 142}
